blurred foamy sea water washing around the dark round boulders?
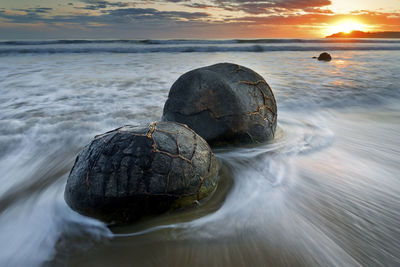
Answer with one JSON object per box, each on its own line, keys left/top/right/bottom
{"left": 0, "top": 39, "right": 400, "bottom": 266}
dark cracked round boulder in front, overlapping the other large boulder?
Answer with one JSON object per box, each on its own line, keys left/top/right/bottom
{"left": 64, "top": 122, "right": 218, "bottom": 224}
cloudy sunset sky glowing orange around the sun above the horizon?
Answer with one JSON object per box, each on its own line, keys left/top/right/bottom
{"left": 0, "top": 0, "right": 400, "bottom": 40}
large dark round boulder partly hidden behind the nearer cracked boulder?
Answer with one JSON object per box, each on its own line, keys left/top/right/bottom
{"left": 162, "top": 63, "right": 277, "bottom": 146}
